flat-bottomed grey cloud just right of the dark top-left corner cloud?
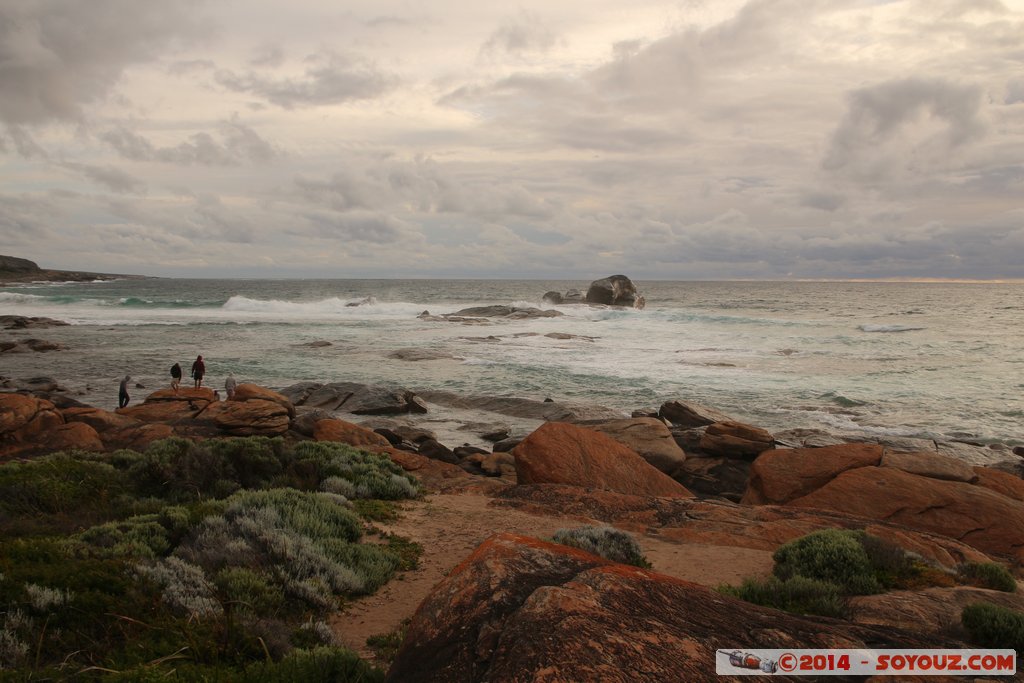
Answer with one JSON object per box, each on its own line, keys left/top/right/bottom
{"left": 216, "top": 52, "right": 397, "bottom": 109}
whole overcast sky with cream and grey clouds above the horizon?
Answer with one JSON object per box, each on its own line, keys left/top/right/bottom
{"left": 0, "top": 0, "right": 1024, "bottom": 280}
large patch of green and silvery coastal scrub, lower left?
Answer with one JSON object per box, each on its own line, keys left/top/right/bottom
{"left": 0, "top": 437, "right": 420, "bottom": 681}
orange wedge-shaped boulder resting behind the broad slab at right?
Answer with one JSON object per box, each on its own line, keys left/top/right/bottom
{"left": 742, "top": 443, "right": 883, "bottom": 505}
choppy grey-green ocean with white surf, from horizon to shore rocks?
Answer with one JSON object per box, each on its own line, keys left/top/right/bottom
{"left": 0, "top": 279, "right": 1024, "bottom": 443}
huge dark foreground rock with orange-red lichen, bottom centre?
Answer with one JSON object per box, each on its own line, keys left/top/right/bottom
{"left": 386, "top": 533, "right": 950, "bottom": 683}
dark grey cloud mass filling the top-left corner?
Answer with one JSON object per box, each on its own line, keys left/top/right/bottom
{"left": 0, "top": 0, "right": 205, "bottom": 125}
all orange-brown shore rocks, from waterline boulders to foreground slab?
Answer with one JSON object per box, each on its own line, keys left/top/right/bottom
{"left": 0, "top": 382, "right": 1024, "bottom": 681}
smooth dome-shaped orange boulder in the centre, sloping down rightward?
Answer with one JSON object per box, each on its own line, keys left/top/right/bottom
{"left": 512, "top": 422, "right": 692, "bottom": 497}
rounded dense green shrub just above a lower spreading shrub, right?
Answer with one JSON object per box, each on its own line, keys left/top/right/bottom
{"left": 772, "top": 529, "right": 882, "bottom": 595}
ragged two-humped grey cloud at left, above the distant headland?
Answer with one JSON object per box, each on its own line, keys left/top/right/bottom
{"left": 99, "top": 119, "right": 283, "bottom": 166}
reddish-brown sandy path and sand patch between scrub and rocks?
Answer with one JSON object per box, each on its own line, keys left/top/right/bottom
{"left": 331, "top": 493, "right": 772, "bottom": 660}
